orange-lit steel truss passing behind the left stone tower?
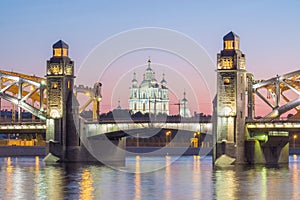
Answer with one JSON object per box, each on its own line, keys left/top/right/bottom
{"left": 0, "top": 70, "right": 102, "bottom": 120}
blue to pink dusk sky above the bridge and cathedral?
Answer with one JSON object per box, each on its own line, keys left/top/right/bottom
{"left": 0, "top": 0, "right": 300, "bottom": 114}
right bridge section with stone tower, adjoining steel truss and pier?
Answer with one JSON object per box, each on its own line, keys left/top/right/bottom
{"left": 214, "top": 32, "right": 300, "bottom": 165}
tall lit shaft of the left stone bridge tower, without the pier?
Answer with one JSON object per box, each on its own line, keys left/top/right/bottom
{"left": 46, "top": 40, "right": 79, "bottom": 157}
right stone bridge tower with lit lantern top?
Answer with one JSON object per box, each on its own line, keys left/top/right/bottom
{"left": 214, "top": 32, "right": 247, "bottom": 163}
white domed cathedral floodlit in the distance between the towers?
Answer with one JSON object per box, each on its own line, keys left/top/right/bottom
{"left": 129, "top": 59, "right": 169, "bottom": 115}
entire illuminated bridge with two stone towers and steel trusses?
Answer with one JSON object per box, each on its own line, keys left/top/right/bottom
{"left": 0, "top": 32, "right": 300, "bottom": 164}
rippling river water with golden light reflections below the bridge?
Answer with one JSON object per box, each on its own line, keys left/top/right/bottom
{"left": 0, "top": 155, "right": 300, "bottom": 200}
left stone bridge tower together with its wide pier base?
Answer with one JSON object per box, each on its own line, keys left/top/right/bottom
{"left": 44, "top": 40, "right": 126, "bottom": 164}
